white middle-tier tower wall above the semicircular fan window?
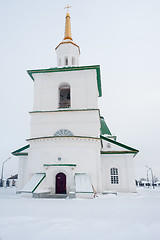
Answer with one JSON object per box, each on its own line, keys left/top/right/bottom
{"left": 31, "top": 110, "right": 100, "bottom": 138}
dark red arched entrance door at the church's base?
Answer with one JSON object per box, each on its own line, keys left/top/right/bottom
{"left": 56, "top": 173, "right": 66, "bottom": 194}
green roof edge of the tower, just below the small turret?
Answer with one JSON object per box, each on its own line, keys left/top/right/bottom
{"left": 27, "top": 65, "right": 102, "bottom": 97}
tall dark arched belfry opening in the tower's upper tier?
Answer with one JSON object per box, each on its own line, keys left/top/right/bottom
{"left": 59, "top": 84, "right": 71, "bottom": 108}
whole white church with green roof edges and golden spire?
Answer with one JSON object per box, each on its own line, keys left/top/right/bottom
{"left": 12, "top": 7, "right": 138, "bottom": 198}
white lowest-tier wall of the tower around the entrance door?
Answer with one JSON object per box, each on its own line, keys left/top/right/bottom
{"left": 28, "top": 138, "right": 101, "bottom": 192}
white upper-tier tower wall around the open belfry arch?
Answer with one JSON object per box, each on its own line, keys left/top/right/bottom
{"left": 33, "top": 69, "right": 98, "bottom": 111}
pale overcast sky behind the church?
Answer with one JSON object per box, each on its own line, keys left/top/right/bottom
{"left": 0, "top": 0, "right": 160, "bottom": 178}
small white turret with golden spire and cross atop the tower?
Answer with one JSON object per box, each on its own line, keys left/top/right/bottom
{"left": 55, "top": 5, "right": 80, "bottom": 67}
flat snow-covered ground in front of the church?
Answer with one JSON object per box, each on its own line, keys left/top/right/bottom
{"left": 0, "top": 188, "right": 160, "bottom": 240}
